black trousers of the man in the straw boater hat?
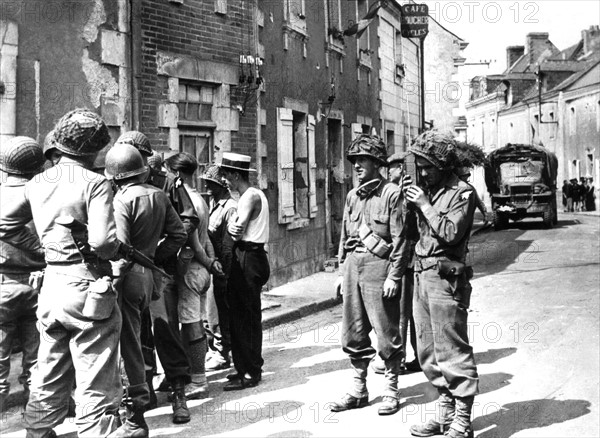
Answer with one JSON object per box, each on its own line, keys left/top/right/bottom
{"left": 227, "top": 242, "right": 271, "bottom": 377}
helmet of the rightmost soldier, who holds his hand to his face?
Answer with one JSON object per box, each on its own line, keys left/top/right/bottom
{"left": 408, "top": 130, "right": 456, "bottom": 170}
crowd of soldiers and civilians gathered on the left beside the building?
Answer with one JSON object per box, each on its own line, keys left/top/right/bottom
{"left": 0, "top": 109, "right": 270, "bottom": 438}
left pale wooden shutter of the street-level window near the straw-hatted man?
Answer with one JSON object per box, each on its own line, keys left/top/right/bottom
{"left": 277, "top": 108, "right": 296, "bottom": 224}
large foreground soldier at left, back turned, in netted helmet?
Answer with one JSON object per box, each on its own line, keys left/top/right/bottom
{"left": 0, "top": 109, "right": 123, "bottom": 438}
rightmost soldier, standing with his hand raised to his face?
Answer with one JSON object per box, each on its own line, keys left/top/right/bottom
{"left": 403, "top": 131, "right": 479, "bottom": 438}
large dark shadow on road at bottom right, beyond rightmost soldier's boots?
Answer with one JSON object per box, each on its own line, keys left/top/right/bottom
{"left": 473, "top": 400, "right": 591, "bottom": 438}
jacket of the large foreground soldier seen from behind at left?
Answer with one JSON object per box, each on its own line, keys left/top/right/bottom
{"left": 0, "top": 156, "right": 119, "bottom": 263}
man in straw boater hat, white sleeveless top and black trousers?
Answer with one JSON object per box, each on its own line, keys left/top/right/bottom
{"left": 218, "top": 152, "right": 270, "bottom": 391}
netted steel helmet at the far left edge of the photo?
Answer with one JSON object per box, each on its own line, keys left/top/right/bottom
{"left": 0, "top": 137, "right": 46, "bottom": 175}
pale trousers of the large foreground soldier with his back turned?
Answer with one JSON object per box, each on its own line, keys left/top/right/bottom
{"left": 24, "top": 264, "right": 123, "bottom": 438}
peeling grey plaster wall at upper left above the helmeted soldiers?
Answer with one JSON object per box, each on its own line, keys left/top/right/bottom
{"left": 2, "top": 0, "right": 127, "bottom": 141}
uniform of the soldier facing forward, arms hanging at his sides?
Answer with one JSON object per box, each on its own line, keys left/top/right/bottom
{"left": 339, "top": 179, "right": 408, "bottom": 398}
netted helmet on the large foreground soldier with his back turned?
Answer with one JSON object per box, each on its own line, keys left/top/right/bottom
{"left": 54, "top": 108, "right": 110, "bottom": 157}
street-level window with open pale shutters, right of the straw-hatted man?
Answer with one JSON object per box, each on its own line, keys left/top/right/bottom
{"left": 277, "top": 108, "right": 318, "bottom": 228}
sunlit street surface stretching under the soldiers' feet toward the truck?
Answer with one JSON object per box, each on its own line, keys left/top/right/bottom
{"left": 0, "top": 213, "right": 600, "bottom": 438}
